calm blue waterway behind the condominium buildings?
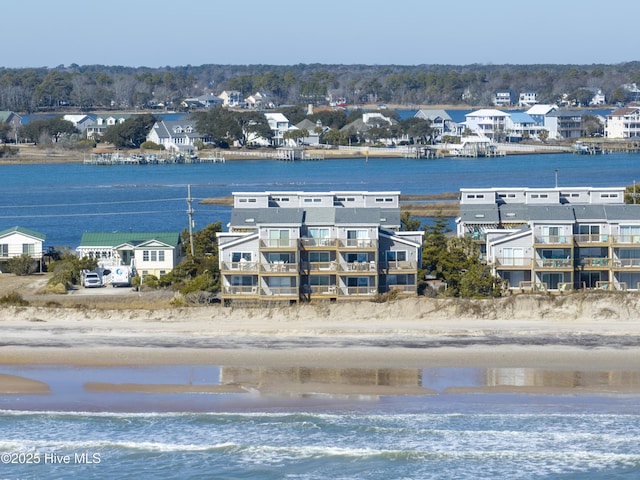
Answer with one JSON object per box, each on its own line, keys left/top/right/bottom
{"left": 0, "top": 154, "right": 640, "bottom": 248}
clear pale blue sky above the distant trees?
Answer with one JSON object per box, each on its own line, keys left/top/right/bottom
{"left": 5, "top": 0, "right": 640, "bottom": 68}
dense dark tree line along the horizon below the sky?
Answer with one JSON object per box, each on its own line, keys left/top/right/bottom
{"left": 0, "top": 62, "right": 640, "bottom": 113}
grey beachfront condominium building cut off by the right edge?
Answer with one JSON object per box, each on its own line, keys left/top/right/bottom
{"left": 456, "top": 187, "right": 640, "bottom": 291}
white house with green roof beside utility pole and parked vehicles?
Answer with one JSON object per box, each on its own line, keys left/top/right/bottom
{"left": 76, "top": 232, "right": 182, "bottom": 277}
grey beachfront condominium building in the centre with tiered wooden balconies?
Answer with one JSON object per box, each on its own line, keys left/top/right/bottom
{"left": 218, "top": 191, "right": 423, "bottom": 304}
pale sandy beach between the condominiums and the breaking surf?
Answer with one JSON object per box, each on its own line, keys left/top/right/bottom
{"left": 0, "top": 294, "right": 640, "bottom": 404}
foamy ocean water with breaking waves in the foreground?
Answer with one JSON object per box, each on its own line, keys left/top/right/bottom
{"left": 0, "top": 397, "right": 640, "bottom": 480}
